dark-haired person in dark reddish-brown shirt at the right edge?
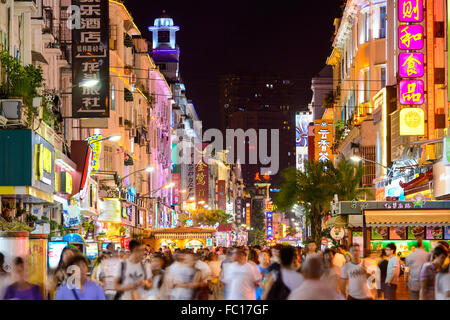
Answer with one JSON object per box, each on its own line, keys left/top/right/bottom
{"left": 420, "top": 246, "right": 448, "bottom": 300}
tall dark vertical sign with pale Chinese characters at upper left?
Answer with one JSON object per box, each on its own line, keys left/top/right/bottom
{"left": 72, "top": 0, "right": 109, "bottom": 118}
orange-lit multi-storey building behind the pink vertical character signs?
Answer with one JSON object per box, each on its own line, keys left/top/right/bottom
{"left": 327, "top": 0, "right": 448, "bottom": 199}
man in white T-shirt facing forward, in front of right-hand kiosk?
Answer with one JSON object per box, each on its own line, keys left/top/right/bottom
{"left": 340, "top": 244, "right": 372, "bottom": 300}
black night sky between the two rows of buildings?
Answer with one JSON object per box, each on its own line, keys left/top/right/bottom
{"left": 125, "top": 0, "right": 342, "bottom": 128}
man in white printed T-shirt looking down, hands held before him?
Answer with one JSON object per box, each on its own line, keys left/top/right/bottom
{"left": 114, "top": 239, "right": 152, "bottom": 300}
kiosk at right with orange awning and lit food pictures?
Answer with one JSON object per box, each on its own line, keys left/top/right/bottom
{"left": 340, "top": 201, "right": 450, "bottom": 257}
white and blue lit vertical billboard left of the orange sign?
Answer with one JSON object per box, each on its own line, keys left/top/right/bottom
{"left": 295, "top": 112, "right": 312, "bottom": 171}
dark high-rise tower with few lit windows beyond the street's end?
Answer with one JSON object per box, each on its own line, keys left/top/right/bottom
{"left": 219, "top": 74, "right": 296, "bottom": 186}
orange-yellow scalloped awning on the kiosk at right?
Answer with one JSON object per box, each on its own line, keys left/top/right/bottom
{"left": 364, "top": 209, "right": 450, "bottom": 227}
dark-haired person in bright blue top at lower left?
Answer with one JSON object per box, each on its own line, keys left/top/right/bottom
{"left": 55, "top": 254, "right": 106, "bottom": 300}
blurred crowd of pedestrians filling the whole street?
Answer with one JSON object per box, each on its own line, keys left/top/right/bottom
{"left": 0, "top": 240, "right": 450, "bottom": 300}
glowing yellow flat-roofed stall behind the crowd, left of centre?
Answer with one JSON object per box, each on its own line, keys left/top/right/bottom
{"left": 144, "top": 227, "right": 216, "bottom": 251}
